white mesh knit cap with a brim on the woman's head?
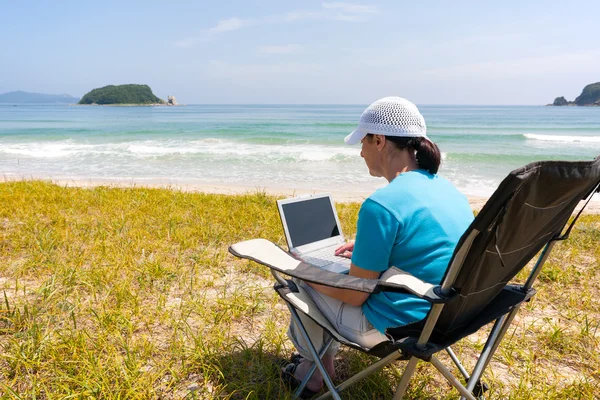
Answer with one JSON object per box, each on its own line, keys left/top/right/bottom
{"left": 344, "top": 96, "right": 429, "bottom": 144}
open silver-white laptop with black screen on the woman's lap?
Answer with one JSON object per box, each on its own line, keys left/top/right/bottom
{"left": 277, "top": 194, "right": 350, "bottom": 274}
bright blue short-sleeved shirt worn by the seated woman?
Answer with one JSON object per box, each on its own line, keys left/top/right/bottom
{"left": 352, "top": 169, "right": 473, "bottom": 332}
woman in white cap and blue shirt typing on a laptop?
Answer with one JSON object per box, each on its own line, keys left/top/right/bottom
{"left": 284, "top": 97, "right": 473, "bottom": 394}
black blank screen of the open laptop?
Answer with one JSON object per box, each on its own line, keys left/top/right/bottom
{"left": 282, "top": 197, "right": 340, "bottom": 247}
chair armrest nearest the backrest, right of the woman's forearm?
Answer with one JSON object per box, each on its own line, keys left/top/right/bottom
{"left": 379, "top": 267, "right": 455, "bottom": 303}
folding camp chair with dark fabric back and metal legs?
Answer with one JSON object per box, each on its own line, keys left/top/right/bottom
{"left": 229, "top": 156, "right": 600, "bottom": 400}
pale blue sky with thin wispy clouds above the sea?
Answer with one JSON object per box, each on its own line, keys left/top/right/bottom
{"left": 0, "top": 0, "right": 600, "bottom": 105}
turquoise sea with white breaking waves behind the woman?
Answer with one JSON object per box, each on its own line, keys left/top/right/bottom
{"left": 0, "top": 105, "right": 600, "bottom": 195}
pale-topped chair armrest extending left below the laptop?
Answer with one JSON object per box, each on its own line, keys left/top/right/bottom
{"left": 229, "top": 239, "right": 379, "bottom": 293}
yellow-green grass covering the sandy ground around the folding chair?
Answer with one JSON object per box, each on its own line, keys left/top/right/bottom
{"left": 0, "top": 181, "right": 600, "bottom": 399}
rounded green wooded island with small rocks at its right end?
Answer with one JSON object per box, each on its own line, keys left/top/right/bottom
{"left": 78, "top": 84, "right": 177, "bottom": 106}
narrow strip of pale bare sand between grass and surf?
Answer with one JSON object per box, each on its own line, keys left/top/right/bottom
{"left": 0, "top": 176, "right": 600, "bottom": 214}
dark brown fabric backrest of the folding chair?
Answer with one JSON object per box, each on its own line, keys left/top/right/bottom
{"left": 390, "top": 156, "right": 600, "bottom": 343}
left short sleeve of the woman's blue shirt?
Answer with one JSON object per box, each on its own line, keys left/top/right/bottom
{"left": 352, "top": 199, "right": 400, "bottom": 272}
